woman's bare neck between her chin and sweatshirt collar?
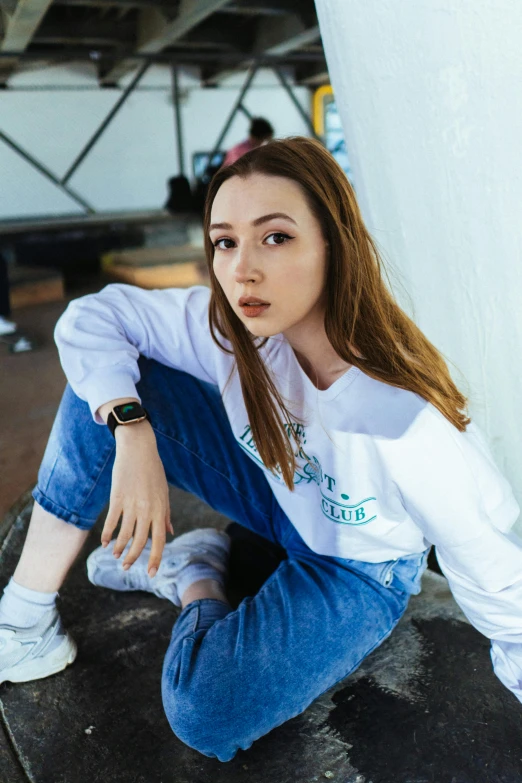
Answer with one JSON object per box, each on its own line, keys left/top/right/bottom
{"left": 284, "top": 314, "right": 351, "bottom": 390}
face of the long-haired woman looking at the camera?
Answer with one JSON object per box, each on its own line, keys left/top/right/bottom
{"left": 210, "top": 174, "right": 327, "bottom": 337}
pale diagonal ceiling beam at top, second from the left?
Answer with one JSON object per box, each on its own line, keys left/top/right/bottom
{"left": 100, "top": 0, "right": 229, "bottom": 84}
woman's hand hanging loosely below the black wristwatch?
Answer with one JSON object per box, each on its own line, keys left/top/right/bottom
{"left": 101, "top": 421, "right": 174, "bottom": 577}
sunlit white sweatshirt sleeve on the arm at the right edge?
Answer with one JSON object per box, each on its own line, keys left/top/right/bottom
{"left": 394, "top": 406, "right": 522, "bottom": 702}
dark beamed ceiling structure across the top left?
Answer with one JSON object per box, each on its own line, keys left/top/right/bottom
{"left": 0, "top": 0, "right": 328, "bottom": 86}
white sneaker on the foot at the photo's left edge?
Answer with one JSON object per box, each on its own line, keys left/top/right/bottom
{"left": 0, "top": 607, "right": 77, "bottom": 683}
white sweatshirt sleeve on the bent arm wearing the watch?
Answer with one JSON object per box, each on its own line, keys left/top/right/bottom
{"left": 54, "top": 284, "right": 219, "bottom": 424}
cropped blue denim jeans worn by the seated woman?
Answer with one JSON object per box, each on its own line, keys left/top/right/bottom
{"left": 33, "top": 358, "right": 427, "bottom": 761}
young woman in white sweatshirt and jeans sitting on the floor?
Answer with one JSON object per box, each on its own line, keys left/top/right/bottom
{"left": 0, "top": 138, "right": 522, "bottom": 761}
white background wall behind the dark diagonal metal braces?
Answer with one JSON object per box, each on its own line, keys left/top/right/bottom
{"left": 0, "top": 64, "right": 310, "bottom": 220}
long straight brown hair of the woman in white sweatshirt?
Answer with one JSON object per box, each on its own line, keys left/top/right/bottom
{"left": 204, "top": 137, "right": 470, "bottom": 489}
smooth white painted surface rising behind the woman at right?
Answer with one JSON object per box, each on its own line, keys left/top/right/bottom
{"left": 317, "top": 0, "right": 522, "bottom": 532}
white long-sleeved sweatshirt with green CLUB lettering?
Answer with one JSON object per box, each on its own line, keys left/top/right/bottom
{"left": 55, "top": 285, "right": 522, "bottom": 702}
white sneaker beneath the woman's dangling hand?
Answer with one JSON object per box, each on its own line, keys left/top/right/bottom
{"left": 87, "top": 527, "right": 230, "bottom": 606}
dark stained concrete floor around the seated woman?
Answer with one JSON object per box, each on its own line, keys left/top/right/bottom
{"left": 0, "top": 284, "right": 522, "bottom": 783}
